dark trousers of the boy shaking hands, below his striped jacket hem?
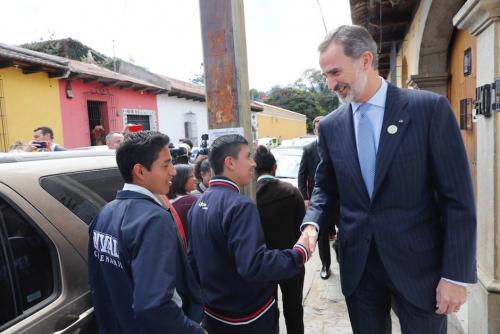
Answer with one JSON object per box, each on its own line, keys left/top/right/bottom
{"left": 205, "top": 303, "right": 280, "bottom": 334}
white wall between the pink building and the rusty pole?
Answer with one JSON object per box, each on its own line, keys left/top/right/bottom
{"left": 157, "top": 94, "right": 208, "bottom": 146}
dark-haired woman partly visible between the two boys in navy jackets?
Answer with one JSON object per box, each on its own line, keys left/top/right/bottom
{"left": 168, "top": 164, "right": 196, "bottom": 237}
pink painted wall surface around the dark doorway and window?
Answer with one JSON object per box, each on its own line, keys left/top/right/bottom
{"left": 59, "top": 80, "right": 158, "bottom": 148}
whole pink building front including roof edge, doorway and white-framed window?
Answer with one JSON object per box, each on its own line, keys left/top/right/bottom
{"left": 59, "top": 60, "right": 166, "bottom": 148}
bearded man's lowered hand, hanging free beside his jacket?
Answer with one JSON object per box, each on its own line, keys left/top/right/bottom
{"left": 436, "top": 279, "right": 467, "bottom": 314}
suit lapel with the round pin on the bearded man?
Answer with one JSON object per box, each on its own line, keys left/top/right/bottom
{"left": 372, "top": 84, "right": 410, "bottom": 198}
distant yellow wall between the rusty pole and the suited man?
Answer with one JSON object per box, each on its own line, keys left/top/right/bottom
{"left": 257, "top": 113, "right": 307, "bottom": 139}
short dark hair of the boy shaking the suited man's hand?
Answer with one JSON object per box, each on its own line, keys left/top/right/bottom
{"left": 208, "top": 135, "right": 248, "bottom": 175}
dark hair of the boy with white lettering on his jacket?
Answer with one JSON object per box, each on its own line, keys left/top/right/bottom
{"left": 116, "top": 131, "right": 170, "bottom": 183}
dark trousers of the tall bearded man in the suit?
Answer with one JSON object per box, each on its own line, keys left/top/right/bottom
{"left": 346, "top": 242, "right": 447, "bottom": 334}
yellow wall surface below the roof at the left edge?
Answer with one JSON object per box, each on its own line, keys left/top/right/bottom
{"left": 0, "top": 67, "right": 64, "bottom": 151}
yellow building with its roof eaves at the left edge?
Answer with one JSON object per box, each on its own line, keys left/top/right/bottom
{"left": 0, "top": 44, "right": 68, "bottom": 152}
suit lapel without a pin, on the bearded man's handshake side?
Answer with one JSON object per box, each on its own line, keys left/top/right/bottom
{"left": 338, "top": 103, "right": 369, "bottom": 200}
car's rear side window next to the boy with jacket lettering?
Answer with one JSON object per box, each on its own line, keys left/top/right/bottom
{"left": 40, "top": 168, "right": 123, "bottom": 225}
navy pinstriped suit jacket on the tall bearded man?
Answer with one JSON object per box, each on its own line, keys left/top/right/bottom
{"left": 304, "top": 85, "right": 477, "bottom": 311}
